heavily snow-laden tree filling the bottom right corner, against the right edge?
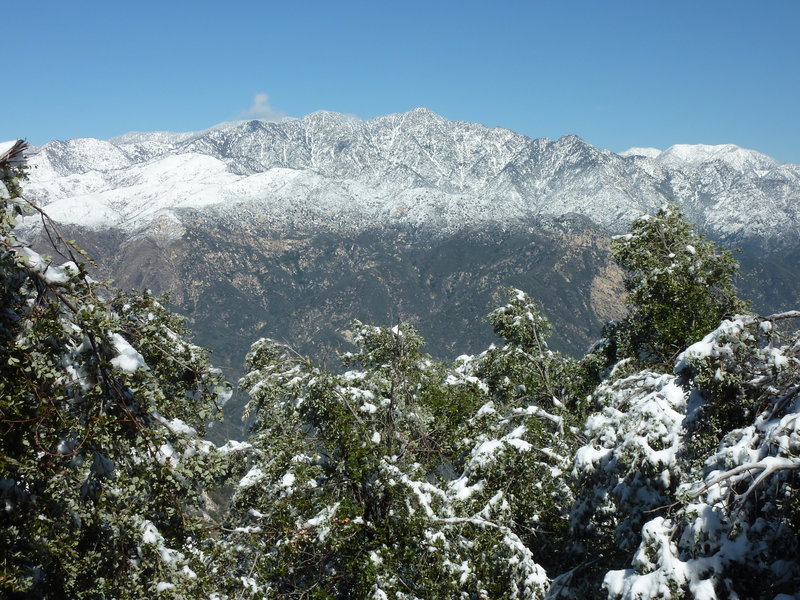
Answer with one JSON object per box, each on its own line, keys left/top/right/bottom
{"left": 605, "top": 312, "right": 800, "bottom": 600}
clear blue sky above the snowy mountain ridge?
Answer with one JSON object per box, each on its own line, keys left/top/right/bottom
{"left": 6, "top": 0, "right": 800, "bottom": 163}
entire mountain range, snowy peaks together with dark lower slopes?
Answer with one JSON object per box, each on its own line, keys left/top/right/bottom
{"left": 17, "top": 109, "right": 800, "bottom": 370}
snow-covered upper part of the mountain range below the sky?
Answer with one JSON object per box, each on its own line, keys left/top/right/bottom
{"left": 23, "top": 109, "right": 800, "bottom": 238}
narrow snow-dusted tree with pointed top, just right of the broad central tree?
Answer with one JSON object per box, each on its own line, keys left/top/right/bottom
{"left": 449, "top": 289, "right": 593, "bottom": 573}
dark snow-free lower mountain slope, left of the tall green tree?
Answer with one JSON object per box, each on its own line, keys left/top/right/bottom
{"left": 43, "top": 217, "right": 622, "bottom": 371}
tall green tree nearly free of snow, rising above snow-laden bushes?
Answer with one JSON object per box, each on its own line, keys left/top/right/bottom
{"left": 611, "top": 205, "right": 747, "bottom": 364}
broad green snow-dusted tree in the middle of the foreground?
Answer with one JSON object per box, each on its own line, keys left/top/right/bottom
{"left": 227, "top": 323, "right": 546, "bottom": 599}
